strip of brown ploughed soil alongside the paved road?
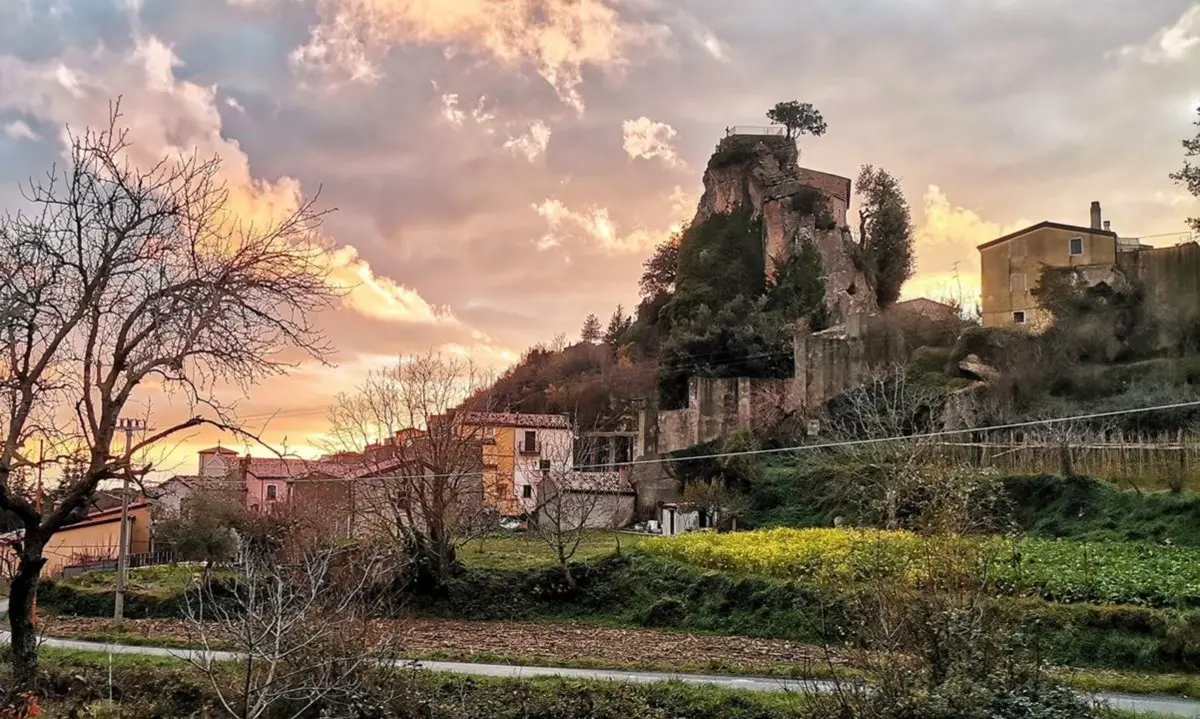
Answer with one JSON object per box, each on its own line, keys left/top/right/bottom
{"left": 43, "top": 617, "right": 826, "bottom": 667}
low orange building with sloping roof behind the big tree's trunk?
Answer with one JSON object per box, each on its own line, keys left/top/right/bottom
{"left": 0, "top": 501, "right": 151, "bottom": 576}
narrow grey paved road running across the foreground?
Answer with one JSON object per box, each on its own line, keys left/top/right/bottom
{"left": 0, "top": 633, "right": 1200, "bottom": 718}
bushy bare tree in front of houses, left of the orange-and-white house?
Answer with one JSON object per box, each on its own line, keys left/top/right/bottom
{"left": 328, "top": 353, "right": 494, "bottom": 581}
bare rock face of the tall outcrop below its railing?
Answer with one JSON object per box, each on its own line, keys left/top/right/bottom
{"left": 694, "top": 134, "right": 877, "bottom": 323}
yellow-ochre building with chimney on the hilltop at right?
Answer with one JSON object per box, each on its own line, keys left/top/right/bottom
{"left": 979, "top": 202, "right": 1118, "bottom": 329}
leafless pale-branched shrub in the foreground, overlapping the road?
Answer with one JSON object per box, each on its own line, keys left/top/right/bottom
{"left": 187, "top": 544, "right": 400, "bottom": 719}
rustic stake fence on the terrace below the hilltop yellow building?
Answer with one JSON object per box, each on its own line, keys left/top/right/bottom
{"left": 942, "top": 431, "right": 1200, "bottom": 489}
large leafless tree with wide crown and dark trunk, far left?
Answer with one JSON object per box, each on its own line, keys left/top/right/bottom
{"left": 0, "top": 103, "right": 334, "bottom": 691}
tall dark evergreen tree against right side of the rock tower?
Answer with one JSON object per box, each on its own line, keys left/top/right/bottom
{"left": 858, "top": 164, "right": 916, "bottom": 307}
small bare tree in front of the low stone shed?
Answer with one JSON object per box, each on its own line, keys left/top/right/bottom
{"left": 529, "top": 437, "right": 630, "bottom": 587}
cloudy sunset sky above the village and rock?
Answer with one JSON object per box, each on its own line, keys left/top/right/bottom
{"left": 0, "top": 0, "right": 1200, "bottom": 472}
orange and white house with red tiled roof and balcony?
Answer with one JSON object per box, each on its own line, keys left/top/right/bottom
{"left": 463, "top": 412, "right": 575, "bottom": 516}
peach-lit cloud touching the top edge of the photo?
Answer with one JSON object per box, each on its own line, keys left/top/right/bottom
{"left": 286, "top": 0, "right": 667, "bottom": 112}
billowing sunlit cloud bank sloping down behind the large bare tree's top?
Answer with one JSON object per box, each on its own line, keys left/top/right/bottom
{"left": 0, "top": 37, "right": 452, "bottom": 323}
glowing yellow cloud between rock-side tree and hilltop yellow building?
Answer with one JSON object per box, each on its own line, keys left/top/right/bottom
{"left": 904, "top": 185, "right": 1032, "bottom": 304}
